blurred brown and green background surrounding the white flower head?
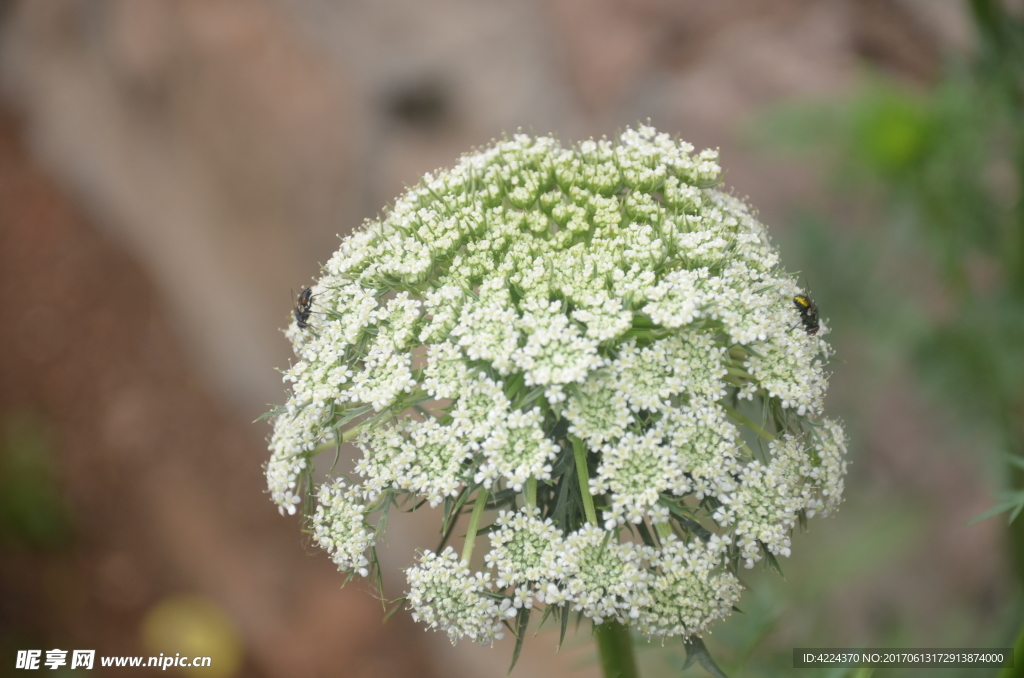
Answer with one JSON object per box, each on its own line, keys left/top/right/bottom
{"left": 0, "top": 0, "right": 1024, "bottom": 678}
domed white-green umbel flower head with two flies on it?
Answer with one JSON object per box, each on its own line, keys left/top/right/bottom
{"left": 266, "top": 126, "right": 846, "bottom": 655}
